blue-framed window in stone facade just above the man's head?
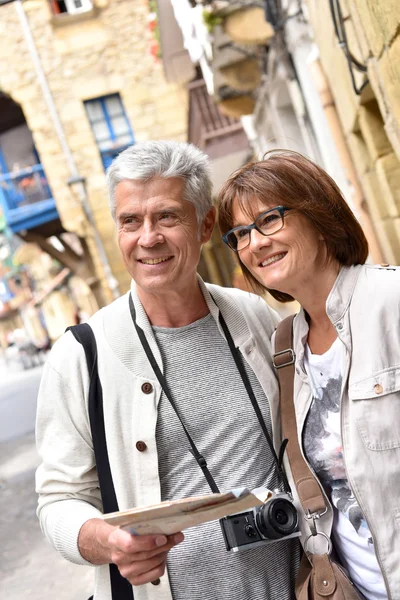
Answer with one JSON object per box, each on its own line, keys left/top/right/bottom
{"left": 85, "top": 94, "right": 135, "bottom": 169}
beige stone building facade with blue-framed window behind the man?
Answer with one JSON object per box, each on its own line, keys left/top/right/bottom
{"left": 0, "top": 0, "right": 187, "bottom": 300}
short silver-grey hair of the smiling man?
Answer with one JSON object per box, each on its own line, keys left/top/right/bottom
{"left": 107, "top": 140, "right": 212, "bottom": 225}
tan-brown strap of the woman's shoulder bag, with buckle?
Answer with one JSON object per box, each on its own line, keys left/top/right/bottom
{"left": 273, "top": 315, "right": 327, "bottom": 524}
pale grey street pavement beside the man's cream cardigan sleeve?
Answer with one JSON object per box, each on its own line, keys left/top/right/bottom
{"left": 0, "top": 362, "right": 94, "bottom": 600}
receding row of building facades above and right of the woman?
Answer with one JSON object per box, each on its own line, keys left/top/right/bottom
{"left": 171, "top": 0, "right": 400, "bottom": 264}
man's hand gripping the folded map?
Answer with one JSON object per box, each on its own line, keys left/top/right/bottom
{"left": 78, "top": 519, "right": 184, "bottom": 585}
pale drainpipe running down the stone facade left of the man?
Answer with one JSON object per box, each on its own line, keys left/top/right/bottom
{"left": 15, "top": 0, "right": 120, "bottom": 299}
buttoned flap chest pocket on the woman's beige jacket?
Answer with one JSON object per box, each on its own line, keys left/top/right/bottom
{"left": 349, "top": 366, "right": 400, "bottom": 451}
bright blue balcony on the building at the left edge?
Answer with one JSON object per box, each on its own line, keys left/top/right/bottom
{"left": 0, "top": 164, "right": 59, "bottom": 233}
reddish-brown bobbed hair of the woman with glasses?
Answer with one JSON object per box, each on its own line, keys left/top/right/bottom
{"left": 217, "top": 150, "right": 368, "bottom": 302}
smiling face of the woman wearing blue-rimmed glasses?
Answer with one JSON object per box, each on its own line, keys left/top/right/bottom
{"left": 233, "top": 199, "right": 326, "bottom": 298}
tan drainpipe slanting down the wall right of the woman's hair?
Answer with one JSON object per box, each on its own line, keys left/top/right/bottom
{"left": 309, "top": 60, "right": 384, "bottom": 263}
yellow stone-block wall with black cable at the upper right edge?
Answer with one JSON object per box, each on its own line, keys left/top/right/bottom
{"left": 307, "top": 0, "right": 400, "bottom": 264}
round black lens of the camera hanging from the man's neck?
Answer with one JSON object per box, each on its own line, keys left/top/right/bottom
{"left": 256, "top": 498, "right": 298, "bottom": 540}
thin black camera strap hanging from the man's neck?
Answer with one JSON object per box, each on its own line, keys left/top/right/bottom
{"left": 129, "top": 294, "right": 290, "bottom": 493}
